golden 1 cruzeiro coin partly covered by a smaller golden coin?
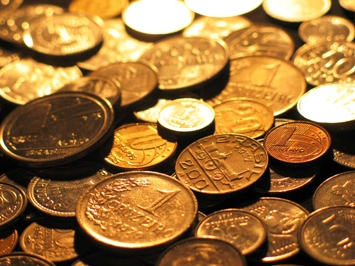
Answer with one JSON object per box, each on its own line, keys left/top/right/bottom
{"left": 206, "top": 56, "right": 307, "bottom": 116}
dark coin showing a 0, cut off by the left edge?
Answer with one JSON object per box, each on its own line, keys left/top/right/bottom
{"left": 0, "top": 183, "right": 27, "bottom": 229}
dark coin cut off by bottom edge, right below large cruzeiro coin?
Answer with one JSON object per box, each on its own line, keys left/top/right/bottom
{"left": 155, "top": 238, "right": 247, "bottom": 266}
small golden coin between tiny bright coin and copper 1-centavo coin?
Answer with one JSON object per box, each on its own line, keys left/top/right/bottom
{"left": 213, "top": 98, "right": 274, "bottom": 138}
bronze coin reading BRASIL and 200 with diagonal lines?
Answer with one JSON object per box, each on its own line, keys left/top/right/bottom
{"left": 175, "top": 133, "right": 269, "bottom": 195}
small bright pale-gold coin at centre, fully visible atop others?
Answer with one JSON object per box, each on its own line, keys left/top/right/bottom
{"left": 158, "top": 98, "right": 215, "bottom": 136}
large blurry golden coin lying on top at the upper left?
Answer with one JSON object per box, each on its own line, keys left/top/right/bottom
{"left": 23, "top": 12, "right": 103, "bottom": 57}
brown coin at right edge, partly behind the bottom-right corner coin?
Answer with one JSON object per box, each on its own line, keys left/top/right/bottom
{"left": 313, "top": 171, "right": 355, "bottom": 209}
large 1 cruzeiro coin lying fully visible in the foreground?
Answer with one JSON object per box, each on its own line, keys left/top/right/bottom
{"left": 76, "top": 171, "right": 197, "bottom": 252}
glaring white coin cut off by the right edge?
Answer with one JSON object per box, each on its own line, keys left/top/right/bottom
{"left": 297, "top": 84, "right": 355, "bottom": 131}
